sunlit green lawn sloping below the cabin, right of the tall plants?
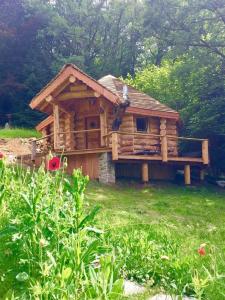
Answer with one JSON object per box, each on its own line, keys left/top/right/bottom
{"left": 87, "top": 183, "right": 225, "bottom": 300}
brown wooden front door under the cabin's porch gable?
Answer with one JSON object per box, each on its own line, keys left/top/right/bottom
{"left": 85, "top": 116, "right": 101, "bottom": 149}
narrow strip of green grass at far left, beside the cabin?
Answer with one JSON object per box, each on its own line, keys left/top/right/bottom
{"left": 0, "top": 128, "right": 40, "bottom": 139}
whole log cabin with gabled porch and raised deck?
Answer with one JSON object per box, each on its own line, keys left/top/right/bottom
{"left": 30, "top": 64, "right": 209, "bottom": 184}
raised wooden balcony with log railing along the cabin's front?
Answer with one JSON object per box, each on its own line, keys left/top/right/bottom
{"left": 32, "top": 129, "right": 209, "bottom": 165}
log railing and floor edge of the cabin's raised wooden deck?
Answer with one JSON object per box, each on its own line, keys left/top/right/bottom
{"left": 32, "top": 129, "right": 209, "bottom": 165}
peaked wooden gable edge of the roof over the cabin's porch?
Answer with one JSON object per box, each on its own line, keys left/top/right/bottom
{"left": 30, "top": 64, "right": 120, "bottom": 111}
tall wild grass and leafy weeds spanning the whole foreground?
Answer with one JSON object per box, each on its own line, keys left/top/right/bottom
{"left": 0, "top": 160, "right": 225, "bottom": 300}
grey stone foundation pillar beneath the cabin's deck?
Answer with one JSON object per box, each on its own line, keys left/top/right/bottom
{"left": 99, "top": 152, "right": 116, "bottom": 183}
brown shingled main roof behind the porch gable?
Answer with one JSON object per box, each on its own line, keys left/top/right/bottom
{"left": 98, "top": 75, "right": 179, "bottom": 119}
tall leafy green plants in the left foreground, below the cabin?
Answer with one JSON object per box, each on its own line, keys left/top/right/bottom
{"left": 0, "top": 161, "right": 123, "bottom": 299}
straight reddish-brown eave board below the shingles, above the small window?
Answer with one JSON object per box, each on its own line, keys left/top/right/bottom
{"left": 126, "top": 107, "right": 180, "bottom": 121}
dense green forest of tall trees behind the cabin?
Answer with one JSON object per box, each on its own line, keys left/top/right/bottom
{"left": 0, "top": 0, "right": 225, "bottom": 170}
